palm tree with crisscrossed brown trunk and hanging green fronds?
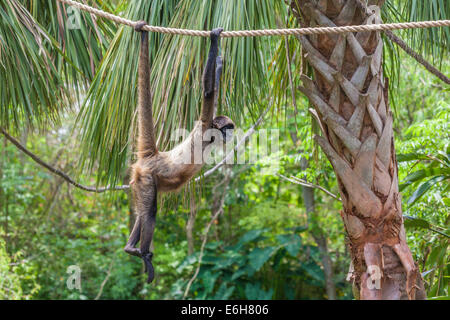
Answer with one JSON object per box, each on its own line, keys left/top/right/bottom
{"left": 0, "top": 0, "right": 450, "bottom": 299}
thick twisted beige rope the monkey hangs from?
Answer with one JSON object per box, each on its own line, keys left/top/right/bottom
{"left": 58, "top": 0, "right": 450, "bottom": 38}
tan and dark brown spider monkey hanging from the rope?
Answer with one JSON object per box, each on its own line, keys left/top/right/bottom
{"left": 124, "top": 21, "right": 235, "bottom": 283}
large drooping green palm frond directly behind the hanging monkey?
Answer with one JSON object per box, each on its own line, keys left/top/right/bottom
{"left": 79, "top": 0, "right": 285, "bottom": 184}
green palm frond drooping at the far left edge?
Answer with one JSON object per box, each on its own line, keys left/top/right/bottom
{"left": 0, "top": 0, "right": 66, "bottom": 130}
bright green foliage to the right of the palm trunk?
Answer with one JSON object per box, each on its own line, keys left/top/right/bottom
{"left": 396, "top": 65, "right": 450, "bottom": 298}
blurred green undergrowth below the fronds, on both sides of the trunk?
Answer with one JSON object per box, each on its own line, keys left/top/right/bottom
{"left": 0, "top": 54, "right": 450, "bottom": 299}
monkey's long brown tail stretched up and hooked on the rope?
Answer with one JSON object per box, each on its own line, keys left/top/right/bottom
{"left": 135, "top": 21, "right": 157, "bottom": 158}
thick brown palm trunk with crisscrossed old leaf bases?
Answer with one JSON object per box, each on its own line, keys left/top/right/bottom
{"left": 291, "top": 0, "right": 423, "bottom": 299}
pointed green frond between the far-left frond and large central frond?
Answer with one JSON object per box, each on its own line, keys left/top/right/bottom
{"left": 24, "top": 0, "right": 117, "bottom": 89}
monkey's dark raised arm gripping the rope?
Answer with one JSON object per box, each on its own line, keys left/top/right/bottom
{"left": 200, "top": 28, "right": 223, "bottom": 127}
